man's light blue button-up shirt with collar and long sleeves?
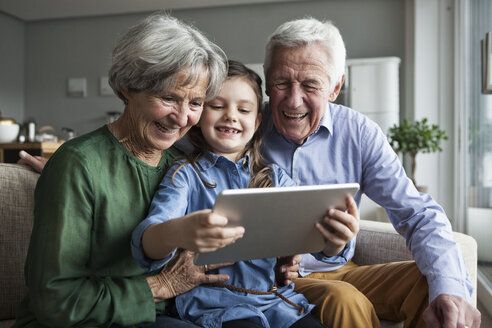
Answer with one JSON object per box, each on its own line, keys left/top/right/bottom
{"left": 262, "top": 103, "right": 473, "bottom": 302}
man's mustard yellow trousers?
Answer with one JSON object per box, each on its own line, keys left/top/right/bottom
{"left": 294, "top": 261, "right": 428, "bottom": 328}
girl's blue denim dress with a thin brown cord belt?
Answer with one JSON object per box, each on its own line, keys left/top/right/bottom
{"left": 132, "top": 153, "right": 314, "bottom": 328}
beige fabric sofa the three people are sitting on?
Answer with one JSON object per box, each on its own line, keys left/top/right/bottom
{"left": 0, "top": 163, "right": 477, "bottom": 328}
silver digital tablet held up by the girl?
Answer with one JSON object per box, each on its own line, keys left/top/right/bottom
{"left": 194, "top": 183, "right": 359, "bottom": 265}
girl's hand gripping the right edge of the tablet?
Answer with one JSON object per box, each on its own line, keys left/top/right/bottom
{"left": 316, "top": 195, "right": 359, "bottom": 256}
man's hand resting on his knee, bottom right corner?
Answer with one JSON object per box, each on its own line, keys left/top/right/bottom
{"left": 423, "top": 294, "right": 481, "bottom": 328}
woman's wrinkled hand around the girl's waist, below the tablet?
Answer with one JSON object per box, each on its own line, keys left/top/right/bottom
{"left": 147, "top": 250, "right": 233, "bottom": 302}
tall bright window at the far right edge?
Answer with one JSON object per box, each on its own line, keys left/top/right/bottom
{"left": 465, "top": 0, "right": 492, "bottom": 311}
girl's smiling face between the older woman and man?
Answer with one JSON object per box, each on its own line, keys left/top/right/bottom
{"left": 199, "top": 77, "right": 261, "bottom": 162}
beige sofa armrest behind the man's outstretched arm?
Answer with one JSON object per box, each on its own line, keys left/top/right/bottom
{"left": 353, "top": 220, "right": 477, "bottom": 306}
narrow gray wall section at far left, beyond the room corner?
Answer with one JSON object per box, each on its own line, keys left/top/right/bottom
{"left": 0, "top": 12, "right": 25, "bottom": 122}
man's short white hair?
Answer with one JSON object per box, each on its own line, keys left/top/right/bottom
{"left": 263, "top": 17, "right": 346, "bottom": 89}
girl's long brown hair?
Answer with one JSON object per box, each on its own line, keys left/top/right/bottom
{"left": 173, "top": 60, "right": 273, "bottom": 188}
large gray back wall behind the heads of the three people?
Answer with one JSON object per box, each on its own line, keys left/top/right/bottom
{"left": 25, "top": 0, "right": 405, "bottom": 133}
